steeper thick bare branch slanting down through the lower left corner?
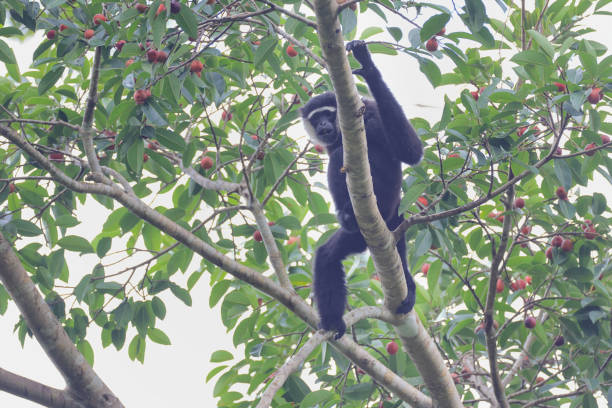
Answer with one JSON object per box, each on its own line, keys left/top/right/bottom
{"left": 0, "top": 231, "right": 123, "bottom": 408}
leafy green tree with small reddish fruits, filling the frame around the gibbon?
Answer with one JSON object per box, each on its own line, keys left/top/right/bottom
{"left": 0, "top": 0, "right": 612, "bottom": 408}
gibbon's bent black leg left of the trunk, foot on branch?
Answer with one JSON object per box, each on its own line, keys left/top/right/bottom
{"left": 314, "top": 228, "right": 366, "bottom": 339}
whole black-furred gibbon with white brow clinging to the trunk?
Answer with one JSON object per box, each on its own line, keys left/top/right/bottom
{"left": 300, "top": 41, "right": 423, "bottom": 339}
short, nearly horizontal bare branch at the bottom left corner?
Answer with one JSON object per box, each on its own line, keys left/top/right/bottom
{"left": 0, "top": 368, "right": 86, "bottom": 408}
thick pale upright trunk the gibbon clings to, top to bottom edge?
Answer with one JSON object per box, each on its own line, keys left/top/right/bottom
{"left": 314, "top": 0, "right": 462, "bottom": 408}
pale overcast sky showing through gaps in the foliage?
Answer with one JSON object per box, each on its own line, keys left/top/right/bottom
{"left": 0, "top": 1, "right": 612, "bottom": 408}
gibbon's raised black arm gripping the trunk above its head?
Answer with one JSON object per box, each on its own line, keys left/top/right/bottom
{"left": 346, "top": 40, "right": 423, "bottom": 164}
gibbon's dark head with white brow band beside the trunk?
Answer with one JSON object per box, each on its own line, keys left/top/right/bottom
{"left": 300, "top": 92, "right": 342, "bottom": 147}
